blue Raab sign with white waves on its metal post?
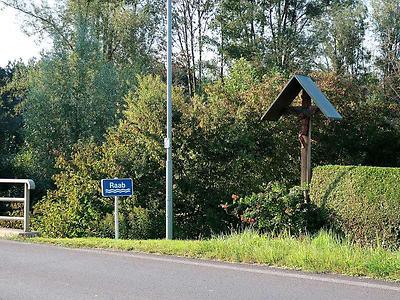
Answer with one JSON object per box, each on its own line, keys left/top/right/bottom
{"left": 101, "top": 178, "right": 133, "bottom": 240}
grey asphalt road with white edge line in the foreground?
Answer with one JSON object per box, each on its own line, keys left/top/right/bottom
{"left": 0, "top": 240, "right": 400, "bottom": 300}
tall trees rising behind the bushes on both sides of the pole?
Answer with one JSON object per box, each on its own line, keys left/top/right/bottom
{"left": 0, "top": 0, "right": 400, "bottom": 180}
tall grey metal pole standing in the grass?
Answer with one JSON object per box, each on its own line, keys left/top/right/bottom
{"left": 165, "top": 0, "right": 173, "bottom": 240}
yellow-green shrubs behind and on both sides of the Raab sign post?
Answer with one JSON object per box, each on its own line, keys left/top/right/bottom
{"left": 32, "top": 143, "right": 159, "bottom": 238}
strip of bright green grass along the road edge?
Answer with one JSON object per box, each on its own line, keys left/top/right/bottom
{"left": 20, "top": 232, "right": 400, "bottom": 281}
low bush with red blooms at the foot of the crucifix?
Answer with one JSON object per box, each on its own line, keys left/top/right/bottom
{"left": 222, "top": 182, "right": 324, "bottom": 235}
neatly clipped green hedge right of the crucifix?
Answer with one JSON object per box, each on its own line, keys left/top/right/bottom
{"left": 310, "top": 166, "right": 400, "bottom": 248}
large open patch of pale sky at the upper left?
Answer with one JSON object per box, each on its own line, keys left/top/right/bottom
{"left": 0, "top": 4, "right": 49, "bottom": 67}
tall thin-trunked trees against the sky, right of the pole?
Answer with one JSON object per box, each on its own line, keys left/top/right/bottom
{"left": 166, "top": 0, "right": 400, "bottom": 100}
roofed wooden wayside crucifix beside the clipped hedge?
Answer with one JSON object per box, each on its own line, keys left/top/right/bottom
{"left": 261, "top": 75, "right": 342, "bottom": 201}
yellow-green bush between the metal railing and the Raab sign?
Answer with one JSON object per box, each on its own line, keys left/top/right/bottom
{"left": 32, "top": 143, "right": 117, "bottom": 237}
